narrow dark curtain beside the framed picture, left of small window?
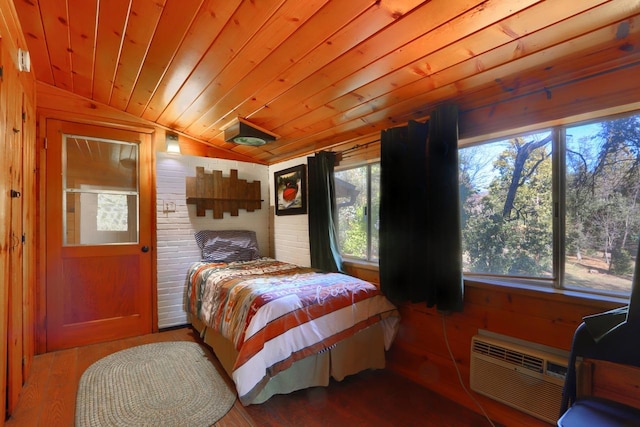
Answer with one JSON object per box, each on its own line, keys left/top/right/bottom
{"left": 307, "top": 151, "right": 343, "bottom": 272}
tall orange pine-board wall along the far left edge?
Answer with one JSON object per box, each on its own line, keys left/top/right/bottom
{"left": 0, "top": 2, "right": 36, "bottom": 425}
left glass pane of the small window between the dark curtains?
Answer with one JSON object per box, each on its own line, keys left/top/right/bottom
{"left": 334, "top": 166, "right": 367, "bottom": 259}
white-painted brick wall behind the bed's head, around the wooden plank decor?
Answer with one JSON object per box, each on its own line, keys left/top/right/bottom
{"left": 156, "top": 152, "right": 268, "bottom": 328}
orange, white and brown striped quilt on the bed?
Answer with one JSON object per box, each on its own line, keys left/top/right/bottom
{"left": 182, "top": 258, "right": 398, "bottom": 404}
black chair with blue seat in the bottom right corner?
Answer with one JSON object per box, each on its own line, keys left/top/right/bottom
{"left": 558, "top": 244, "right": 640, "bottom": 427}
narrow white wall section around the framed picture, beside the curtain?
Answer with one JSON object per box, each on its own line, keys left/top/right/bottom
{"left": 269, "top": 156, "right": 311, "bottom": 267}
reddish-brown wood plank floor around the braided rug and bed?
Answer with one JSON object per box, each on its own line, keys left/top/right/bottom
{"left": 5, "top": 328, "right": 490, "bottom": 427}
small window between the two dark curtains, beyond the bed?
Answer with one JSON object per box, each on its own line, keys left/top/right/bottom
{"left": 334, "top": 163, "right": 380, "bottom": 262}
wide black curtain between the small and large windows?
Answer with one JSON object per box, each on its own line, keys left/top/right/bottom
{"left": 379, "top": 106, "right": 464, "bottom": 311}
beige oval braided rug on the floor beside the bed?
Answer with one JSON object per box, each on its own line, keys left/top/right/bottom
{"left": 76, "top": 341, "right": 236, "bottom": 427}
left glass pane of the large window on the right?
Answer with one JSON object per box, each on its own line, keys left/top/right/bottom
{"left": 459, "top": 132, "right": 553, "bottom": 278}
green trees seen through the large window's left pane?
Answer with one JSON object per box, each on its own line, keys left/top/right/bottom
{"left": 461, "top": 138, "right": 553, "bottom": 276}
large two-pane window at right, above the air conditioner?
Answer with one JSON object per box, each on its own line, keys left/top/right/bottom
{"left": 459, "top": 115, "right": 640, "bottom": 293}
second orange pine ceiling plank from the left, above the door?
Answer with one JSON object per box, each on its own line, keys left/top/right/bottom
{"left": 39, "top": 0, "right": 73, "bottom": 92}
